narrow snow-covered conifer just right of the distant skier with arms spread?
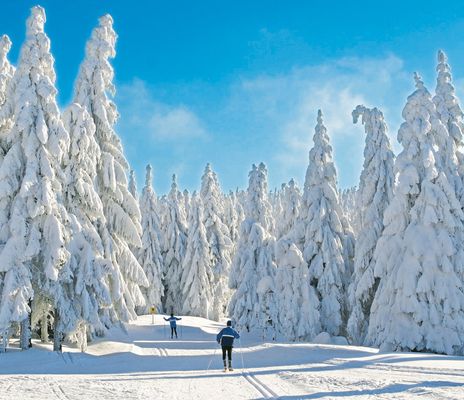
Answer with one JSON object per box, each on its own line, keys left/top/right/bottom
{"left": 181, "top": 192, "right": 213, "bottom": 318}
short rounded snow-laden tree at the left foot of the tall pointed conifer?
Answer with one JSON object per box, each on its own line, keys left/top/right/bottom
{"left": 275, "top": 236, "right": 321, "bottom": 340}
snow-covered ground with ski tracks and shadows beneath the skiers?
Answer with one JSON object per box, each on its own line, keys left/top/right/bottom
{"left": 0, "top": 316, "right": 464, "bottom": 400}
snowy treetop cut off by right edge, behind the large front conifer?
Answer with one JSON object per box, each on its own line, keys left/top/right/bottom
{"left": 433, "top": 50, "right": 464, "bottom": 207}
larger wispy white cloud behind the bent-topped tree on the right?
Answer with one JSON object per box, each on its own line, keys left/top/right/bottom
{"left": 226, "top": 55, "right": 413, "bottom": 185}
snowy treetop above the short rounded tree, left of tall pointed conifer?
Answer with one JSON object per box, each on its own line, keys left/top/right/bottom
{"left": 276, "top": 179, "right": 301, "bottom": 238}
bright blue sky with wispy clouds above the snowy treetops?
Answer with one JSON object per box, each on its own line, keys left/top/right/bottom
{"left": 0, "top": 0, "right": 464, "bottom": 193}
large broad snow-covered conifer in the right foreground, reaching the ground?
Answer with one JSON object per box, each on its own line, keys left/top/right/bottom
{"left": 366, "top": 75, "right": 464, "bottom": 354}
